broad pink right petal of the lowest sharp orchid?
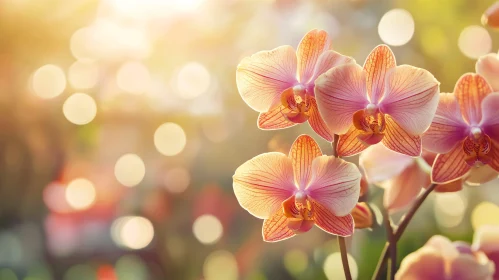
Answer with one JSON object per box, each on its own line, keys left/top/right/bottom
{"left": 306, "top": 156, "right": 361, "bottom": 216}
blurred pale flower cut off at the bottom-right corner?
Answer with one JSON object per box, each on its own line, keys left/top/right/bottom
{"left": 471, "top": 225, "right": 499, "bottom": 280}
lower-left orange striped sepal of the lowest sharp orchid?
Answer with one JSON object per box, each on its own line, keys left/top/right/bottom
{"left": 262, "top": 209, "right": 296, "bottom": 242}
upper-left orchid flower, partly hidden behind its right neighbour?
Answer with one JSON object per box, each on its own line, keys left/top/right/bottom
{"left": 236, "top": 29, "right": 353, "bottom": 142}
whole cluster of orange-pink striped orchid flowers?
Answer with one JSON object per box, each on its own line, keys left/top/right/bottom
{"left": 233, "top": 26, "right": 499, "bottom": 279}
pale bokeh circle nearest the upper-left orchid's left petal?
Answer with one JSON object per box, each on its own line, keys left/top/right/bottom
{"left": 177, "top": 62, "right": 211, "bottom": 99}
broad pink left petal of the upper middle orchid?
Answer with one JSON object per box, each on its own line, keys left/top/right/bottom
{"left": 315, "top": 63, "right": 369, "bottom": 134}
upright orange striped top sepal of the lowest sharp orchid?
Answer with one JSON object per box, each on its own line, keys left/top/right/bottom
{"left": 288, "top": 135, "right": 322, "bottom": 189}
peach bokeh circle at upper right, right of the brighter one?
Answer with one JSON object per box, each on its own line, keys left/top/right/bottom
{"left": 458, "top": 25, "right": 492, "bottom": 59}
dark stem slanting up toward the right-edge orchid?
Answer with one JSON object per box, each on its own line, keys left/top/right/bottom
{"left": 372, "top": 184, "right": 437, "bottom": 280}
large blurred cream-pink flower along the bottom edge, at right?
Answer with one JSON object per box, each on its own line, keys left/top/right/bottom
{"left": 395, "top": 235, "right": 494, "bottom": 280}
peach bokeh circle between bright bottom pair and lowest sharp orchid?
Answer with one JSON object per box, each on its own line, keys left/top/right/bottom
{"left": 192, "top": 214, "right": 223, "bottom": 244}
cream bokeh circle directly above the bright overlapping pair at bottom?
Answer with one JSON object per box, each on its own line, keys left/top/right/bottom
{"left": 114, "top": 154, "right": 146, "bottom": 187}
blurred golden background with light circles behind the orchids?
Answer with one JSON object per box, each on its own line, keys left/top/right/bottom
{"left": 0, "top": 0, "right": 499, "bottom": 280}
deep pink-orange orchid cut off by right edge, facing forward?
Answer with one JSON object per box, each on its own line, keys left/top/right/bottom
{"left": 423, "top": 73, "right": 499, "bottom": 183}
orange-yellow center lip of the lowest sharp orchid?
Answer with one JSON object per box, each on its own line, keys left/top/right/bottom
{"left": 282, "top": 191, "right": 315, "bottom": 234}
